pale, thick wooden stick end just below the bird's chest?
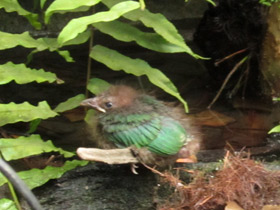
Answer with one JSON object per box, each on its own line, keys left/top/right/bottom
{"left": 77, "top": 147, "right": 139, "bottom": 164}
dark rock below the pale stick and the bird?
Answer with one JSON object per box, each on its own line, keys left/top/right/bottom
{"left": 34, "top": 163, "right": 156, "bottom": 210}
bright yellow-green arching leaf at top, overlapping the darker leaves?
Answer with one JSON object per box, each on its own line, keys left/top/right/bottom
{"left": 58, "top": 1, "right": 139, "bottom": 45}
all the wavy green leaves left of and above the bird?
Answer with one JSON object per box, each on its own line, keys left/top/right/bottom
{"left": 0, "top": 0, "right": 201, "bottom": 209}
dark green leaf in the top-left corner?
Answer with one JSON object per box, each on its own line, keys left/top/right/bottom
{"left": 0, "top": 0, "right": 41, "bottom": 29}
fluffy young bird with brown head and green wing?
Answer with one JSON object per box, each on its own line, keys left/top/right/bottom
{"left": 81, "top": 85, "right": 199, "bottom": 167}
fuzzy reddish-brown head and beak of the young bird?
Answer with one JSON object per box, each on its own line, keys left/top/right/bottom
{"left": 81, "top": 85, "right": 139, "bottom": 113}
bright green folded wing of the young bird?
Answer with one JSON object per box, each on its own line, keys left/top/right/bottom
{"left": 101, "top": 114, "right": 186, "bottom": 155}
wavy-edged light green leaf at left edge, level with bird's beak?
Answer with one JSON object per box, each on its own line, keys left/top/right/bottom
{"left": 0, "top": 101, "right": 57, "bottom": 126}
